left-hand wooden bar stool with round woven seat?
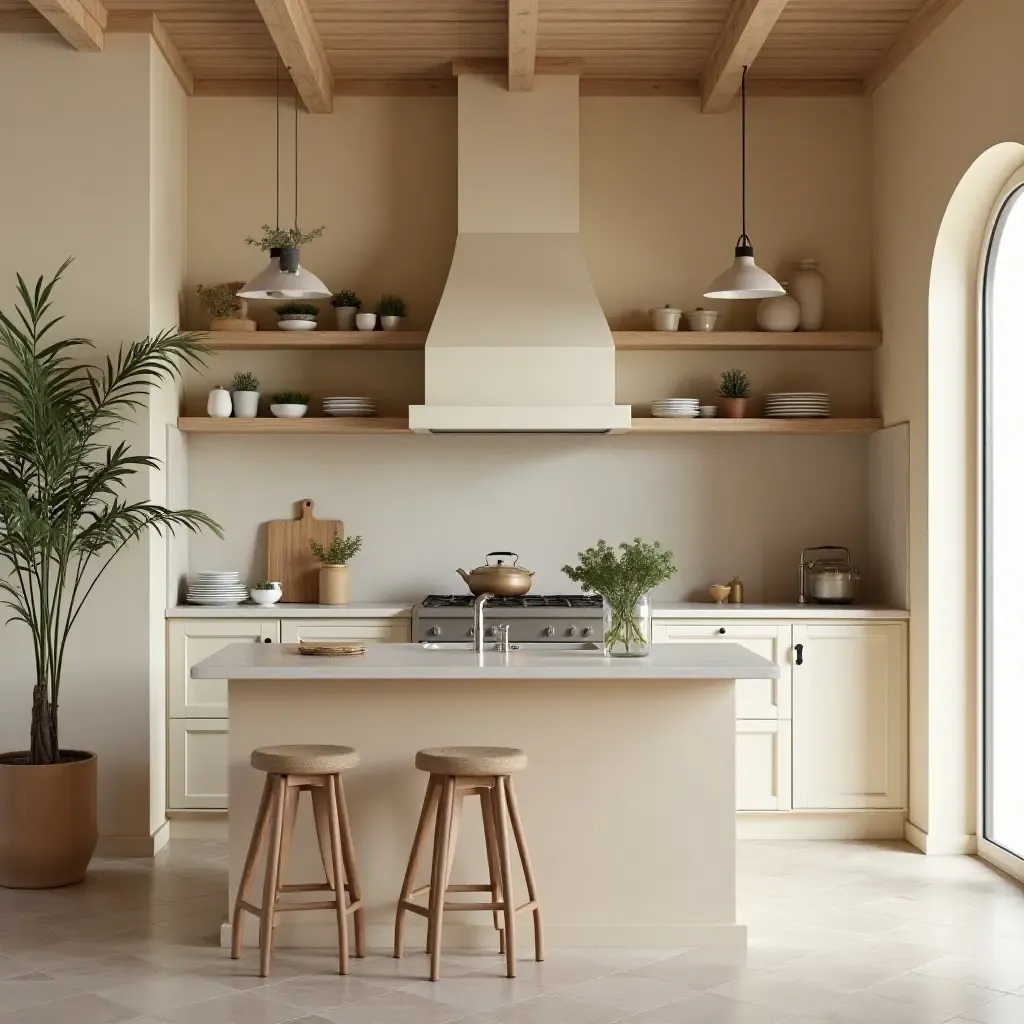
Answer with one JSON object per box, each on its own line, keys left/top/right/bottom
{"left": 231, "top": 744, "right": 366, "bottom": 978}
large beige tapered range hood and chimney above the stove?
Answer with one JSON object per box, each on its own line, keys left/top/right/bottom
{"left": 409, "top": 75, "right": 631, "bottom": 433}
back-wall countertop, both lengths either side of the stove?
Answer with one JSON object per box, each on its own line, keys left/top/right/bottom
{"left": 166, "top": 601, "right": 910, "bottom": 621}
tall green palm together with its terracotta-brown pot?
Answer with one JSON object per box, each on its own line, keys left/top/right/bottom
{"left": 0, "top": 260, "right": 220, "bottom": 889}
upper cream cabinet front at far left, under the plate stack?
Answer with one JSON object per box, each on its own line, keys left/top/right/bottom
{"left": 167, "top": 618, "right": 279, "bottom": 718}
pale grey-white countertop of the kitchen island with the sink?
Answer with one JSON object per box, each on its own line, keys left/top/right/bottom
{"left": 191, "top": 643, "right": 780, "bottom": 682}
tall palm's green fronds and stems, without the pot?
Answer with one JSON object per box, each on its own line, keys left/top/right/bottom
{"left": 0, "top": 260, "right": 221, "bottom": 765}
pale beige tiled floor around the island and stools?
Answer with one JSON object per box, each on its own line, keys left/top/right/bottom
{"left": 0, "top": 842, "right": 1024, "bottom": 1024}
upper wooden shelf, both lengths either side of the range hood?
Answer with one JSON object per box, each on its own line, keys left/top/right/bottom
{"left": 199, "top": 331, "right": 882, "bottom": 352}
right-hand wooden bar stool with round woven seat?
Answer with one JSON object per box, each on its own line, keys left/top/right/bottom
{"left": 394, "top": 746, "right": 544, "bottom": 981}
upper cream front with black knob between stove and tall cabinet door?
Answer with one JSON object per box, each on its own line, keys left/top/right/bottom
{"left": 653, "top": 621, "right": 792, "bottom": 719}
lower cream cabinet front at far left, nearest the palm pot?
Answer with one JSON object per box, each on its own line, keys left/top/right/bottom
{"left": 167, "top": 718, "right": 227, "bottom": 810}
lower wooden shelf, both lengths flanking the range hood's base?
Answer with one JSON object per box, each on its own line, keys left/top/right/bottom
{"left": 178, "top": 416, "right": 882, "bottom": 435}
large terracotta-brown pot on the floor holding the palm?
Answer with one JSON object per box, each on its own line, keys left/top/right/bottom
{"left": 0, "top": 751, "right": 97, "bottom": 889}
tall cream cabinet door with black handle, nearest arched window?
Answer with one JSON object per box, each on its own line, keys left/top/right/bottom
{"left": 793, "top": 623, "right": 906, "bottom": 810}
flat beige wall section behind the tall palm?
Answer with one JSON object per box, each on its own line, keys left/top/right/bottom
{"left": 0, "top": 29, "right": 188, "bottom": 853}
